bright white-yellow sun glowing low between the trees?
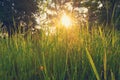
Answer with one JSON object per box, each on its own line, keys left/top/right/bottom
{"left": 61, "top": 14, "right": 72, "bottom": 27}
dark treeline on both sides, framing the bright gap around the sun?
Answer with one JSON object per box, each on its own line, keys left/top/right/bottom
{"left": 0, "top": 0, "right": 120, "bottom": 36}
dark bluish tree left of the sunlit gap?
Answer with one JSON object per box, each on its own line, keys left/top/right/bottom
{"left": 0, "top": 0, "right": 38, "bottom": 36}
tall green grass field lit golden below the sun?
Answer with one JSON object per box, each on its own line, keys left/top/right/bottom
{"left": 0, "top": 27, "right": 120, "bottom": 80}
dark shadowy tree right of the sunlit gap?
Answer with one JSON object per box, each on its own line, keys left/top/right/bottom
{"left": 81, "top": 0, "right": 120, "bottom": 27}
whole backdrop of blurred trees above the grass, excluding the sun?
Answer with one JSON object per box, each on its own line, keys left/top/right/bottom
{"left": 0, "top": 0, "right": 120, "bottom": 35}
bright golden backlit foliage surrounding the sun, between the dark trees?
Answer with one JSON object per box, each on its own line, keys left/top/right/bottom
{"left": 36, "top": 0, "right": 88, "bottom": 27}
